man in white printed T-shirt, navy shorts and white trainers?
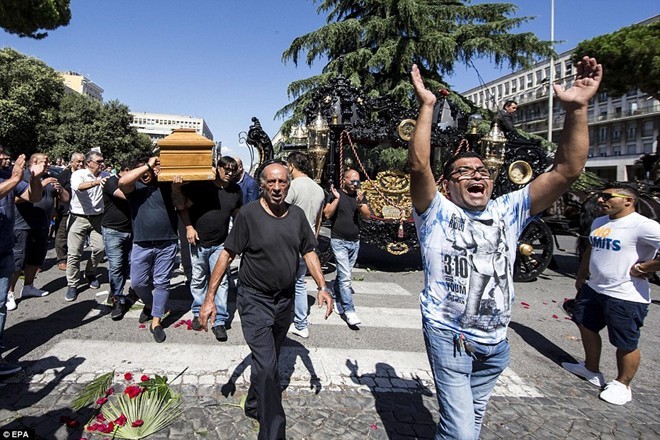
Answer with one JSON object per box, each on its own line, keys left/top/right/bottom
{"left": 562, "top": 184, "right": 660, "bottom": 405}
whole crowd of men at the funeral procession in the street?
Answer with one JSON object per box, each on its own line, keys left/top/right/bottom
{"left": 0, "top": 57, "right": 660, "bottom": 439}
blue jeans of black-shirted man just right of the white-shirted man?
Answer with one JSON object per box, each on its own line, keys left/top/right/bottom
{"left": 103, "top": 227, "right": 133, "bottom": 298}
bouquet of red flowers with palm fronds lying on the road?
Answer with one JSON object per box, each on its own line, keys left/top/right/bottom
{"left": 67, "top": 371, "right": 181, "bottom": 439}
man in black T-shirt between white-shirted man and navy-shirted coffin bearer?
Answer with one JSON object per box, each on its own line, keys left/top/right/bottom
{"left": 102, "top": 162, "right": 133, "bottom": 321}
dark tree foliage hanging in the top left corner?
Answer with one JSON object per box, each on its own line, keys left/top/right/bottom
{"left": 0, "top": 0, "right": 71, "bottom": 39}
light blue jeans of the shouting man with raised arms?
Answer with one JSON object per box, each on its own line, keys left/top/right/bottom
{"left": 423, "top": 320, "right": 509, "bottom": 440}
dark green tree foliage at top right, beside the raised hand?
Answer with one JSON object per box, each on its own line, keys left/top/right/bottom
{"left": 573, "top": 21, "right": 660, "bottom": 99}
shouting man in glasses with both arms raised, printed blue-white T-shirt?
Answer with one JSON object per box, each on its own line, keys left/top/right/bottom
{"left": 408, "top": 57, "right": 602, "bottom": 439}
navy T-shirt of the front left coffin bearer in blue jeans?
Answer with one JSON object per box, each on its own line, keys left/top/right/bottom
{"left": 126, "top": 181, "right": 179, "bottom": 243}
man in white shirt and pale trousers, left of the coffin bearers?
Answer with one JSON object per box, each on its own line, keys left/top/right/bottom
{"left": 64, "top": 150, "right": 108, "bottom": 301}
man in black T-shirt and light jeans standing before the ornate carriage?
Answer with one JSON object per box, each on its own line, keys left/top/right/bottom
{"left": 323, "top": 170, "right": 371, "bottom": 326}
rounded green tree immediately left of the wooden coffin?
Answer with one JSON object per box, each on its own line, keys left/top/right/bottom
{"left": 50, "top": 93, "right": 151, "bottom": 165}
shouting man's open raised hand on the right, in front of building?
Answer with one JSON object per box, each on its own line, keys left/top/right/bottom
{"left": 552, "top": 56, "right": 603, "bottom": 110}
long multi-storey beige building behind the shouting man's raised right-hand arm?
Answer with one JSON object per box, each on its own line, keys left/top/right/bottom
{"left": 463, "top": 16, "right": 660, "bottom": 181}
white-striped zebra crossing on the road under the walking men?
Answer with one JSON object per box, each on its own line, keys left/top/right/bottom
{"left": 34, "top": 270, "right": 542, "bottom": 397}
